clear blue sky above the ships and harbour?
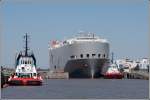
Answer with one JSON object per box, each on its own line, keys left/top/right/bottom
{"left": 0, "top": 0, "right": 150, "bottom": 68}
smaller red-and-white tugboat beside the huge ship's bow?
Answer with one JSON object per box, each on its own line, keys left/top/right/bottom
{"left": 104, "top": 64, "right": 123, "bottom": 79}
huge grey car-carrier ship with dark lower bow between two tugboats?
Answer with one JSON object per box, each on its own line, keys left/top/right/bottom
{"left": 49, "top": 33, "right": 109, "bottom": 78}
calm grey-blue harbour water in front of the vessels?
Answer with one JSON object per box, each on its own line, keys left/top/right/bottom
{"left": 1, "top": 79, "right": 149, "bottom": 99}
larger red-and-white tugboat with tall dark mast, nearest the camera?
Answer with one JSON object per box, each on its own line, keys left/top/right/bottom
{"left": 8, "top": 33, "right": 43, "bottom": 85}
